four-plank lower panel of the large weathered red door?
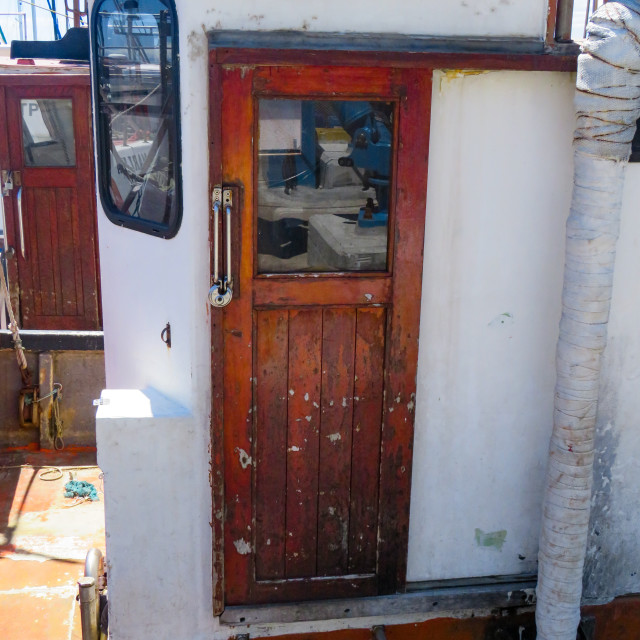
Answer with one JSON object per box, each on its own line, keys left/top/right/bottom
{"left": 254, "top": 307, "right": 385, "bottom": 581}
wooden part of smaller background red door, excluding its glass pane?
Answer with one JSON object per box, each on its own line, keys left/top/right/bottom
{"left": 3, "top": 84, "right": 101, "bottom": 330}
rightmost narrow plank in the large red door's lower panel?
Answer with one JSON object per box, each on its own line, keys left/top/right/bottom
{"left": 349, "top": 309, "right": 386, "bottom": 573}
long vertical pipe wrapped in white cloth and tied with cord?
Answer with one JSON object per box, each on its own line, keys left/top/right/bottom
{"left": 536, "top": 0, "right": 640, "bottom": 640}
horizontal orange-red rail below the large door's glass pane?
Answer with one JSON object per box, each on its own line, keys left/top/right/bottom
{"left": 253, "top": 276, "right": 392, "bottom": 307}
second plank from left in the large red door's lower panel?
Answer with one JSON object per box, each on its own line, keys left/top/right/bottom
{"left": 285, "top": 309, "right": 322, "bottom": 578}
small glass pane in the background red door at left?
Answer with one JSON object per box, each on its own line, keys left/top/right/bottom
{"left": 20, "top": 98, "right": 76, "bottom": 167}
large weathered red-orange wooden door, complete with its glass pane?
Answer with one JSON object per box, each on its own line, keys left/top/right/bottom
{"left": 210, "top": 63, "right": 431, "bottom": 611}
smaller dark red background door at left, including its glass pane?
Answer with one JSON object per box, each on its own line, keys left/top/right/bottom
{"left": 0, "top": 80, "right": 101, "bottom": 330}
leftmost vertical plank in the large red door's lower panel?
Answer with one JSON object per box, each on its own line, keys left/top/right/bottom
{"left": 254, "top": 310, "right": 289, "bottom": 580}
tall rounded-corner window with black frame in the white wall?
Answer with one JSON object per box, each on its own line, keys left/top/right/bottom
{"left": 92, "top": 0, "right": 182, "bottom": 238}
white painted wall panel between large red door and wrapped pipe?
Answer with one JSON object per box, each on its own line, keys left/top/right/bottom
{"left": 408, "top": 72, "right": 575, "bottom": 580}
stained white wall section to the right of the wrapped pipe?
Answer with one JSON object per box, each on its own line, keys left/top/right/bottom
{"left": 584, "top": 164, "right": 640, "bottom": 600}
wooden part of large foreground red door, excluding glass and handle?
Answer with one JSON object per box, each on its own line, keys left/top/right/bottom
{"left": 210, "top": 63, "right": 431, "bottom": 610}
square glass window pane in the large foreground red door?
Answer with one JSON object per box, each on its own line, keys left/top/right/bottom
{"left": 257, "top": 99, "right": 393, "bottom": 273}
